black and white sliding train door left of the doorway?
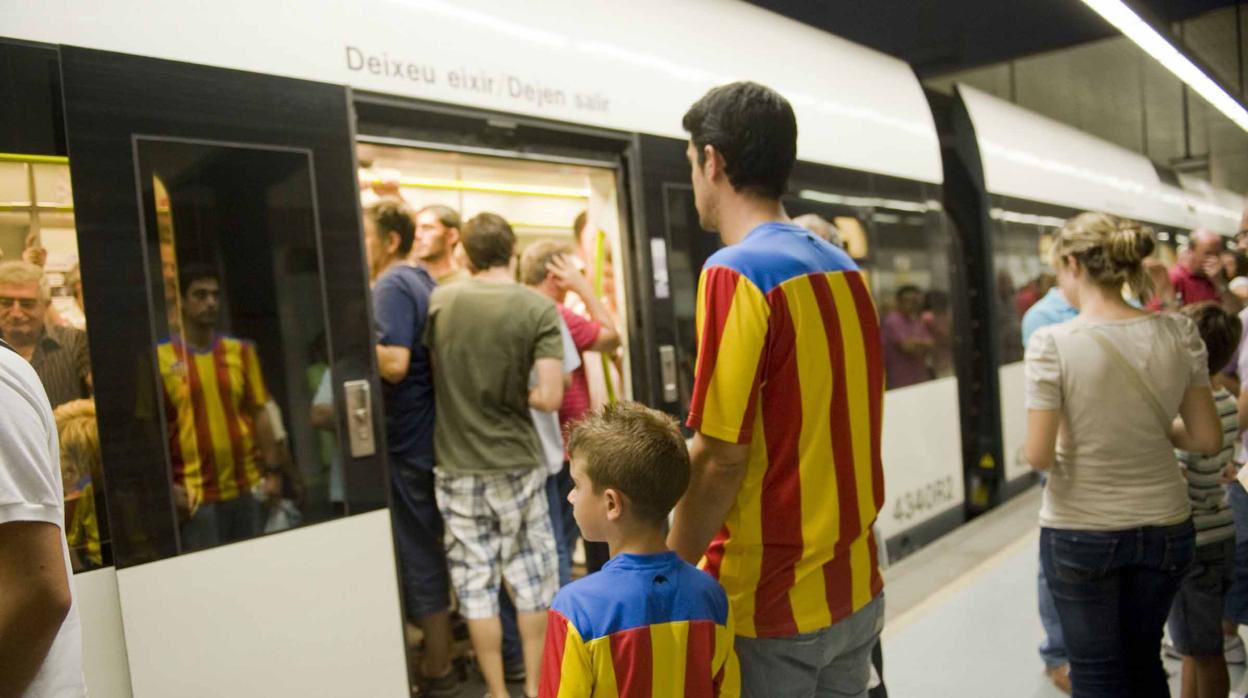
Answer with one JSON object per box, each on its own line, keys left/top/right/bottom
{"left": 60, "top": 46, "right": 408, "bottom": 697}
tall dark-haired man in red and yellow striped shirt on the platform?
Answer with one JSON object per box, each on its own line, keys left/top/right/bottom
{"left": 669, "top": 82, "right": 884, "bottom": 696}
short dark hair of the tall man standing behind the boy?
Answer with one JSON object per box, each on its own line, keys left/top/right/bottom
{"left": 680, "top": 82, "right": 797, "bottom": 199}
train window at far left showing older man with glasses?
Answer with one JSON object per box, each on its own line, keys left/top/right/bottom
{"left": 0, "top": 154, "right": 112, "bottom": 572}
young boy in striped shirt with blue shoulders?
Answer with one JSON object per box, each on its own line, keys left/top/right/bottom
{"left": 539, "top": 402, "right": 740, "bottom": 698}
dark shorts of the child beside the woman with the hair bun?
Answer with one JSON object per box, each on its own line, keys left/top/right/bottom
{"left": 1167, "top": 539, "right": 1236, "bottom": 657}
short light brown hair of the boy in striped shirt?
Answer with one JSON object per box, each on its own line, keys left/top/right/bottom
{"left": 568, "top": 402, "right": 689, "bottom": 524}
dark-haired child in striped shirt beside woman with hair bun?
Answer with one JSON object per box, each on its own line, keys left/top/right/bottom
{"left": 1168, "top": 301, "right": 1242, "bottom": 698}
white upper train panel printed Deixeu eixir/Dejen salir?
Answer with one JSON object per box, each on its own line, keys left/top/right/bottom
{"left": 0, "top": 0, "right": 943, "bottom": 182}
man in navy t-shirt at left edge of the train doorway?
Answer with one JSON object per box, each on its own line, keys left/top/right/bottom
{"left": 364, "top": 200, "right": 458, "bottom": 696}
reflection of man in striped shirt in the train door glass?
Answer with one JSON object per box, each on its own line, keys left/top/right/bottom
{"left": 156, "top": 263, "right": 282, "bottom": 552}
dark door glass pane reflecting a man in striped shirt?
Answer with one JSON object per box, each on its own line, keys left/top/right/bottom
{"left": 135, "top": 139, "right": 344, "bottom": 552}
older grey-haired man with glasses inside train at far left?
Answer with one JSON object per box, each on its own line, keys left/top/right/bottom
{"left": 0, "top": 261, "right": 91, "bottom": 410}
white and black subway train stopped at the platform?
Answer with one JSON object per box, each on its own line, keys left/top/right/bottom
{"left": 0, "top": 0, "right": 1242, "bottom": 697}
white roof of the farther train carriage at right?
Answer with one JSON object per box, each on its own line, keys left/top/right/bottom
{"left": 957, "top": 85, "right": 1243, "bottom": 235}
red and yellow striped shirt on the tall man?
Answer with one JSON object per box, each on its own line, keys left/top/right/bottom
{"left": 688, "top": 224, "right": 884, "bottom": 637}
